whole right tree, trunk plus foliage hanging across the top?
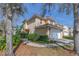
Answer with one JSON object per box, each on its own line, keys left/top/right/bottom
{"left": 43, "top": 3, "right": 79, "bottom": 55}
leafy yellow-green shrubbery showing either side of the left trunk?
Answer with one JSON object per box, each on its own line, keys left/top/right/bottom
{"left": 0, "top": 35, "right": 21, "bottom": 50}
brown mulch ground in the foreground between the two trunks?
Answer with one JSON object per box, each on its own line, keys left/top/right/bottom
{"left": 15, "top": 43, "right": 75, "bottom": 56}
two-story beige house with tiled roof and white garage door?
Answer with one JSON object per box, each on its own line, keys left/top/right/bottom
{"left": 22, "top": 15, "right": 63, "bottom": 39}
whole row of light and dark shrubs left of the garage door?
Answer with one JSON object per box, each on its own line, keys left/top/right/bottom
{"left": 28, "top": 33, "right": 49, "bottom": 43}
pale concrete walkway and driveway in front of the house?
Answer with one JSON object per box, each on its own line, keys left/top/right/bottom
{"left": 24, "top": 39, "right": 74, "bottom": 48}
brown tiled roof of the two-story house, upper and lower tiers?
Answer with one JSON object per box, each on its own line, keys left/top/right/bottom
{"left": 26, "top": 15, "right": 63, "bottom": 30}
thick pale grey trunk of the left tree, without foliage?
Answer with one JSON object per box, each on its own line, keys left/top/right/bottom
{"left": 5, "top": 4, "right": 13, "bottom": 56}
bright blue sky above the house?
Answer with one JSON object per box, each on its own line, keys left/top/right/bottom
{"left": 0, "top": 3, "right": 74, "bottom": 27}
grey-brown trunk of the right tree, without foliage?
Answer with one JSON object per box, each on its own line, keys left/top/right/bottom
{"left": 73, "top": 3, "right": 79, "bottom": 55}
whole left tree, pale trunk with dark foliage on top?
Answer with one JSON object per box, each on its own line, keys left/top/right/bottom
{"left": 0, "top": 3, "right": 24, "bottom": 56}
